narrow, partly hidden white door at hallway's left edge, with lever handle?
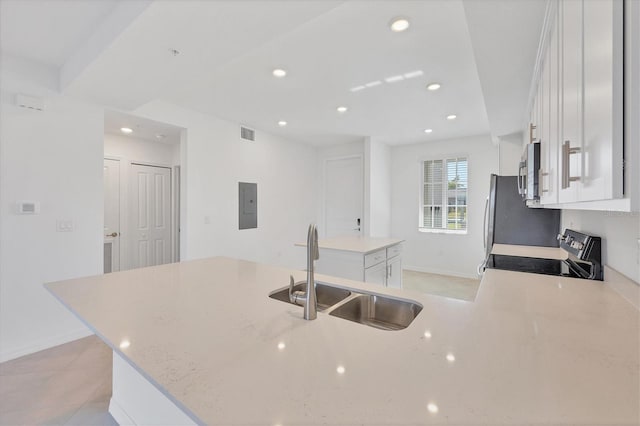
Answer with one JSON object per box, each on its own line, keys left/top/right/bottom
{"left": 104, "top": 158, "right": 120, "bottom": 274}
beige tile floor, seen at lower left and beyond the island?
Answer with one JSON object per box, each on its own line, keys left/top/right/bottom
{"left": 0, "top": 271, "right": 480, "bottom": 426}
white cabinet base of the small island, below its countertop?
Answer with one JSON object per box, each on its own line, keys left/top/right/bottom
{"left": 316, "top": 244, "right": 402, "bottom": 288}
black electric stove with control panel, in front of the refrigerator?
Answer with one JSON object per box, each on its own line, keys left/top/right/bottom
{"left": 486, "top": 229, "right": 603, "bottom": 281}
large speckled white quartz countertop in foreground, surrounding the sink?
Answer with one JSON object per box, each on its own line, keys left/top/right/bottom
{"left": 46, "top": 257, "right": 640, "bottom": 426}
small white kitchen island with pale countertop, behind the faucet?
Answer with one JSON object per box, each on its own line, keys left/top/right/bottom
{"left": 296, "top": 236, "right": 404, "bottom": 288}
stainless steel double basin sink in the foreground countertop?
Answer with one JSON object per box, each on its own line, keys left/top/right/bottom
{"left": 269, "top": 282, "right": 422, "bottom": 330}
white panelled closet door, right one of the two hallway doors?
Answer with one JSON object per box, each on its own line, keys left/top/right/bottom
{"left": 129, "top": 164, "right": 171, "bottom": 268}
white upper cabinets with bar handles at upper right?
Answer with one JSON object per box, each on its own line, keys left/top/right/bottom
{"left": 531, "top": 0, "right": 624, "bottom": 206}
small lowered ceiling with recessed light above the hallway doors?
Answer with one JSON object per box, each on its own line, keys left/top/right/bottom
{"left": 104, "top": 110, "right": 182, "bottom": 144}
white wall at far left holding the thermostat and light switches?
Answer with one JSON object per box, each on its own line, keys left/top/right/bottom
{"left": 0, "top": 57, "right": 104, "bottom": 361}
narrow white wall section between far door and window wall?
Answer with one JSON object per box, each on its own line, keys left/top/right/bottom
{"left": 364, "top": 138, "right": 391, "bottom": 237}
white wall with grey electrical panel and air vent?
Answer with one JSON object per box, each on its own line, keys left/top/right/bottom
{"left": 135, "top": 102, "right": 317, "bottom": 270}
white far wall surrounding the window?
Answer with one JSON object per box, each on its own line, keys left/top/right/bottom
{"left": 391, "top": 135, "right": 499, "bottom": 277}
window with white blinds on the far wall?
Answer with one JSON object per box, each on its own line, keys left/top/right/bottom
{"left": 419, "top": 157, "right": 468, "bottom": 233}
